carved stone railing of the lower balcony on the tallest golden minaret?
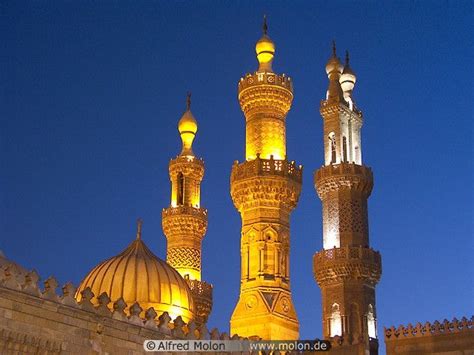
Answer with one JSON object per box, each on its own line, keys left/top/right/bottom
{"left": 230, "top": 155, "right": 303, "bottom": 183}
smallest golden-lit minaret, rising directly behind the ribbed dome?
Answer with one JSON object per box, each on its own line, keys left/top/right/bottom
{"left": 162, "top": 94, "right": 212, "bottom": 324}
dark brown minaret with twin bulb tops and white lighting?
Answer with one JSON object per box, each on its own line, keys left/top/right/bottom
{"left": 313, "top": 44, "right": 382, "bottom": 355}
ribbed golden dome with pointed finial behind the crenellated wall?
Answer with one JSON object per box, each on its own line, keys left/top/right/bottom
{"left": 76, "top": 220, "right": 194, "bottom": 323}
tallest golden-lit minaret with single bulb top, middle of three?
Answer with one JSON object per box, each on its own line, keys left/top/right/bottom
{"left": 230, "top": 21, "right": 302, "bottom": 340}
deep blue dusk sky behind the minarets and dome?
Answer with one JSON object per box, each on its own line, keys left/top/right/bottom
{"left": 0, "top": 1, "right": 474, "bottom": 350}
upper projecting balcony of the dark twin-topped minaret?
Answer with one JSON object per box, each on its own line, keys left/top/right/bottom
{"left": 314, "top": 163, "right": 374, "bottom": 199}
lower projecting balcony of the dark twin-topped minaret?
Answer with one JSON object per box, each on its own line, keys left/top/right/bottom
{"left": 313, "top": 246, "right": 382, "bottom": 287}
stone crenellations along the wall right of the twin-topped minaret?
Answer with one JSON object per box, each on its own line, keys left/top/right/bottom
{"left": 384, "top": 316, "right": 474, "bottom": 341}
